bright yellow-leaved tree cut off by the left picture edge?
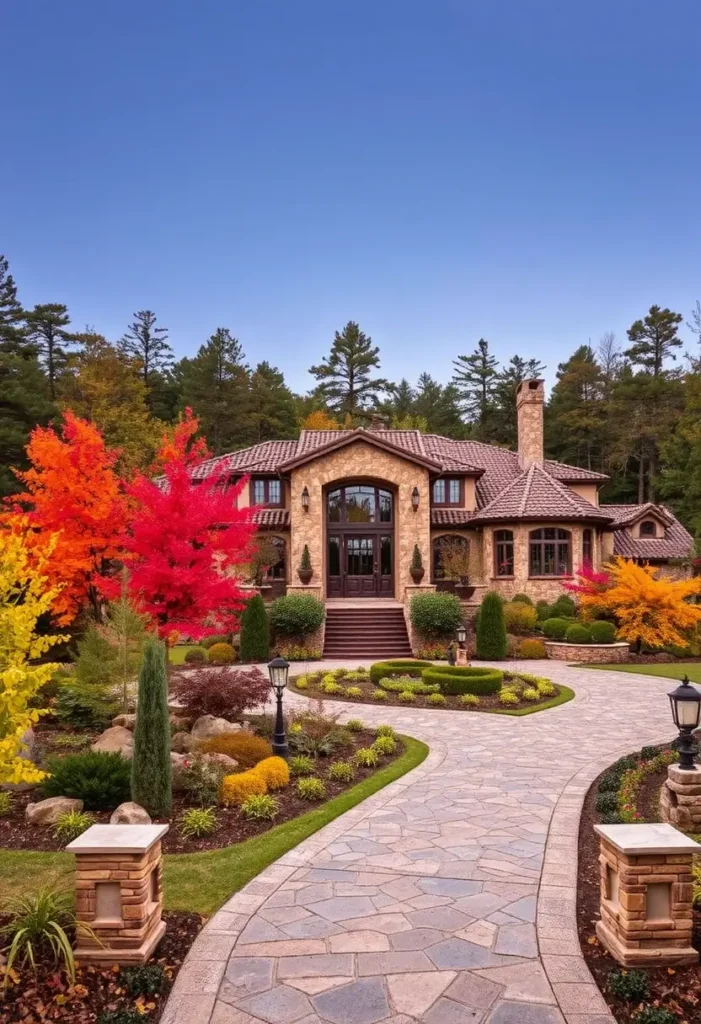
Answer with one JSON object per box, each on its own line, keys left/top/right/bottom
{"left": 0, "top": 529, "right": 68, "bottom": 783}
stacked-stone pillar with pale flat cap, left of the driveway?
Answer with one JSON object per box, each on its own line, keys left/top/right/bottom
{"left": 65, "top": 825, "right": 169, "bottom": 964}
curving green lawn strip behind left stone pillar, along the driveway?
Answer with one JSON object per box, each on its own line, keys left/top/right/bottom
{"left": 0, "top": 736, "right": 429, "bottom": 914}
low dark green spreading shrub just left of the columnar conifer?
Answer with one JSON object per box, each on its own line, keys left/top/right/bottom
{"left": 41, "top": 753, "right": 130, "bottom": 811}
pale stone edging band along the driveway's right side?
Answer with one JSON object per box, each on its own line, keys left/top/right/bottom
{"left": 535, "top": 733, "right": 671, "bottom": 1024}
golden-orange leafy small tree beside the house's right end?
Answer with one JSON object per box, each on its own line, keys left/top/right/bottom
{"left": 579, "top": 557, "right": 701, "bottom": 649}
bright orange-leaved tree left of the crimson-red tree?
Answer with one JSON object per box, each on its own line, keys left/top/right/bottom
{"left": 3, "top": 410, "right": 127, "bottom": 626}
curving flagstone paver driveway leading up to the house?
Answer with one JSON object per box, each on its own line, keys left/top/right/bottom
{"left": 163, "top": 662, "right": 672, "bottom": 1024}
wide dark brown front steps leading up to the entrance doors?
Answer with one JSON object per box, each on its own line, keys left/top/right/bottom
{"left": 323, "top": 600, "right": 412, "bottom": 668}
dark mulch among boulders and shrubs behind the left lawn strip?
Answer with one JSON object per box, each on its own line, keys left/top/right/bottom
{"left": 0, "top": 729, "right": 404, "bottom": 853}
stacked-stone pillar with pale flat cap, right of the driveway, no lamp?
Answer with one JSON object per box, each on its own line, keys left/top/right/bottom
{"left": 595, "top": 824, "right": 701, "bottom": 967}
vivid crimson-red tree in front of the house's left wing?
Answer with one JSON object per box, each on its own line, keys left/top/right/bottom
{"left": 107, "top": 409, "right": 256, "bottom": 643}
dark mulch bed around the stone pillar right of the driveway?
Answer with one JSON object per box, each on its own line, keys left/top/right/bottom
{"left": 577, "top": 768, "right": 701, "bottom": 1024}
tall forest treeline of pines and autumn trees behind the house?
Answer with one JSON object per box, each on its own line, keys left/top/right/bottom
{"left": 0, "top": 250, "right": 701, "bottom": 535}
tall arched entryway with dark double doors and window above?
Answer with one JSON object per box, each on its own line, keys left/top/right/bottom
{"left": 324, "top": 481, "right": 396, "bottom": 597}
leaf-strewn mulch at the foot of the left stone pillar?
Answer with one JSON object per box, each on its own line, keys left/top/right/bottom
{"left": 0, "top": 911, "right": 205, "bottom": 1024}
